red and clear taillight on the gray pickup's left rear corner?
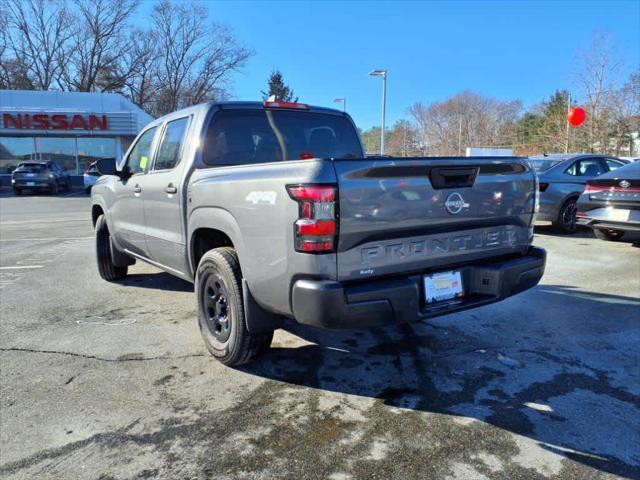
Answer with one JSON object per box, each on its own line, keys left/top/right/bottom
{"left": 287, "top": 185, "right": 338, "bottom": 253}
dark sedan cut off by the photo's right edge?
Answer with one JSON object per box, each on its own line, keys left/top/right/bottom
{"left": 577, "top": 162, "right": 640, "bottom": 241}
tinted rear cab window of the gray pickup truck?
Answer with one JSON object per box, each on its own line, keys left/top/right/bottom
{"left": 203, "top": 109, "right": 364, "bottom": 166}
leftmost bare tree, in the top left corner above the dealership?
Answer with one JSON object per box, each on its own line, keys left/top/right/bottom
{"left": 2, "top": 0, "right": 72, "bottom": 90}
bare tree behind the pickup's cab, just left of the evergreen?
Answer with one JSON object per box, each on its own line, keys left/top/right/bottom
{"left": 153, "top": 0, "right": 250, "bottom": 114}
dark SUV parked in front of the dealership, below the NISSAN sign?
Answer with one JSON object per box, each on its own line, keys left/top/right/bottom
{"left": 11, "top": 161, "right": 71, "bottom": 195}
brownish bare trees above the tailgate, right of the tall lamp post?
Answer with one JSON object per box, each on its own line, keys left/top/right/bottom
{"left": 409, "top": 92, "right": 522, "bottom": 155}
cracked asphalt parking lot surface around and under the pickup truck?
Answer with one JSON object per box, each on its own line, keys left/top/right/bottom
{"left": 0, "top": 193, "right": 640, "bottom": 480}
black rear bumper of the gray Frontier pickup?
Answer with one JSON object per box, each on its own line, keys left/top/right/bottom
{"left": 292, "top": 247, "right": 547, "bottom": 329}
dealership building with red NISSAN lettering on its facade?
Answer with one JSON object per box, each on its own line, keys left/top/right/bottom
{"left": 0, "top": 90, "right": 153, "bottom": 178}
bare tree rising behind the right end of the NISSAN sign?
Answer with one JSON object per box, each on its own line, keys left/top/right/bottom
{"left": 64, "top": 0, "right": 138, "bottom": 92}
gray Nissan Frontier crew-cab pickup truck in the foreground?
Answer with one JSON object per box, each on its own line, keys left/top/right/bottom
{"left": 91, "top": 102, "right": 546, "bottom": 365}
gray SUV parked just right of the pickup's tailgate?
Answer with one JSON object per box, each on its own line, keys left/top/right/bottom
{"left": 529, "top": 153, "right": 626, "bottom": 233}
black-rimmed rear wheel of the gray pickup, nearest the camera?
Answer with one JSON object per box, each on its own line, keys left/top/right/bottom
{"left": 195, "top": 247, "right": 273, "bottom": 367}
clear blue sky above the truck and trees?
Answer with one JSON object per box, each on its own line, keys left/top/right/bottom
{"left": 134, "top": 0, "right": 640, "bottom": 129}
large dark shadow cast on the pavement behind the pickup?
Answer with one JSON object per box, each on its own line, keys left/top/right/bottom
{"left": 244, "top": 285, "right": 640, "bottom": 478}
